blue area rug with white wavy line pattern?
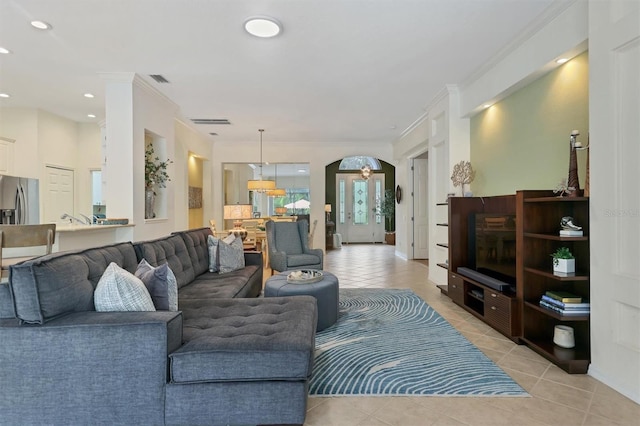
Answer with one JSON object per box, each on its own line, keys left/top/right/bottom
{"left": 309, "top": 289, "right": 528, "bottom": 396}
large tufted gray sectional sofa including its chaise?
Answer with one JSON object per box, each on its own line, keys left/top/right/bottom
{"left": 0, "top": 228, "right": 317, "bottom": 425}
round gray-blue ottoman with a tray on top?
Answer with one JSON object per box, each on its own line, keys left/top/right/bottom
{"left": 264, "top": 271, "right": 339, "bottom": 331}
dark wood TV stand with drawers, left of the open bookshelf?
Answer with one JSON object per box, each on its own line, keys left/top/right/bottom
{"left": 440, "top": 195, "right": 521, "bottom": 343}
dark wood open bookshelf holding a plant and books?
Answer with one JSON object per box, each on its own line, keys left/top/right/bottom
{"left": 516, "top": 191, "right": 591, "bottom": 374}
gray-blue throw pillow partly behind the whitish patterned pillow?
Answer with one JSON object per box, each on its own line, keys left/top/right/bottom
{"left": 135, "top": 259, "right": 178, "bottom": 312}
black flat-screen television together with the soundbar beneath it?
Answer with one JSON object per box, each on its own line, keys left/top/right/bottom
{"left": 458, "top": 213, "right": 516, "bottom": 291}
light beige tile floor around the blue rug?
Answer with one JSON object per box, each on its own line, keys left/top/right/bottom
{"left": 296, "top": 244, "right": 640, "bottom": 426}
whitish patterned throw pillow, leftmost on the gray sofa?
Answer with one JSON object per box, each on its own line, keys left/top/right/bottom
{"left": 93, "top": 262, "right": 156, "bottom": 312}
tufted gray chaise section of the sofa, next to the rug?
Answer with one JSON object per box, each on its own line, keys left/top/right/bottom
{"left": 166, "top": 296, "right": 317, "bottom": 425}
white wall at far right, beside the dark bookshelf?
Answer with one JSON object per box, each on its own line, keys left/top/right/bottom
{"left": 589, "top": 1, "right": 640, "bottom": 403}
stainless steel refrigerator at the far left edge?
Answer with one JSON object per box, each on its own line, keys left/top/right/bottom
{"left": 0, "top": 175, "right": 40, "bottom": 225}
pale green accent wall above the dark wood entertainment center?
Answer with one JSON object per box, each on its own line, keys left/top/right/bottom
{"left": 471, "top": 52, "right": 589, "bottom": 196}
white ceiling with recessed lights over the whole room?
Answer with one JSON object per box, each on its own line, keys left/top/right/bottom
{"left": 0, "top": 0, "right": 574, "bottom": 143}
